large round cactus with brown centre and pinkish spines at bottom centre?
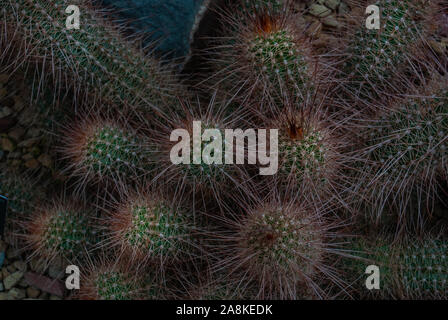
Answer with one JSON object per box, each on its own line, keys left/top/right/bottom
{"left": 228, "top": 203, "right": 329, "bottom": 299}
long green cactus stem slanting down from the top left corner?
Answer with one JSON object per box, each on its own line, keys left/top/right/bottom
{"left": 0, "top": 0, "right": 182, "bottom": 114}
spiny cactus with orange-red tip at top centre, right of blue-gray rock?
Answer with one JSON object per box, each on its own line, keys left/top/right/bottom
{"left": 205, "top": 3, "right": 324, "bottom": 112}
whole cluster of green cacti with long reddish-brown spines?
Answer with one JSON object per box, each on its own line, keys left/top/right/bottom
{"left": 0, "top": 0, "right": 448, "bottom": 300}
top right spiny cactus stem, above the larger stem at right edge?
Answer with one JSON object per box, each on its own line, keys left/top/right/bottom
{"left": 342, "top": 0, "right": 438, "bottom": 106}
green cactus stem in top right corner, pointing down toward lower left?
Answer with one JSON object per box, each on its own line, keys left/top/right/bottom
{"left": 345, "top": 0, "right": 431, "bottom": 102}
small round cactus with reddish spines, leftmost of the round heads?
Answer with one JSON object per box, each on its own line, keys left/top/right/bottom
{"left": 21, "top": 200, "right": 96, "bottom": 265}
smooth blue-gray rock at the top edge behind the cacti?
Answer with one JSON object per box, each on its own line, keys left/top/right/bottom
{"left": 98, "top": 0, "right": 209, "bottom": 58}
